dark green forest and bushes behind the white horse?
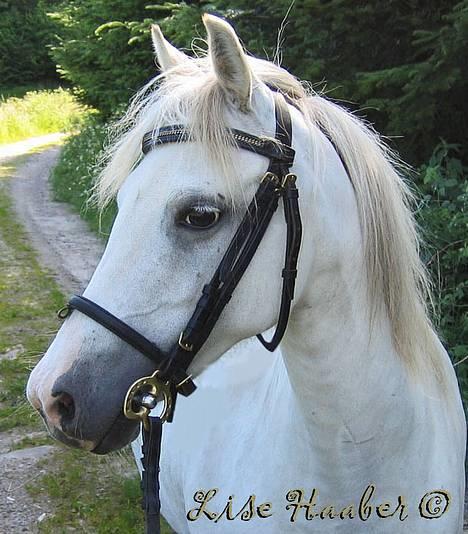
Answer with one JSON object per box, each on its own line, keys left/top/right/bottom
{"left": 0, "top": 0, "right": 468, "bottom": 398}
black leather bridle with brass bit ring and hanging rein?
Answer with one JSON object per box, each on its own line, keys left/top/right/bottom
{"left": 60, "top": 94, "right": 302, "bottom": 534}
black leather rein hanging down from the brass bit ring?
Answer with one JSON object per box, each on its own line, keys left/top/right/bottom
{"left": 141, "top": 416, "right": 162, "bottom": 534}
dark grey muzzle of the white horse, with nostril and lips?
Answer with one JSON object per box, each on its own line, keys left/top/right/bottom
{"left": 27, "top": 351, "right": 153, "bottom": 454}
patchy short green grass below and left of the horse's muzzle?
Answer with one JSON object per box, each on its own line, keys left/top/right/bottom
{"left": 0, "top": 151, "right": 170, "bottom": 534}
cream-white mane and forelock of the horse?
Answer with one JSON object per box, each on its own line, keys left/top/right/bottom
{"left": 95, "top": 53, "right": 446, "bottom": 390}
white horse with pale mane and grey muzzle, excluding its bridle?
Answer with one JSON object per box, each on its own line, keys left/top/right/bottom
{"left": 28, "top": 16, "right": 466, "bottom": 534}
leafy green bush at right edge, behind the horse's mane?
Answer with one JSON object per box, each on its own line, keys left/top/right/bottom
{"left": 417, "top": 143, "right": 468, "bottom": 400}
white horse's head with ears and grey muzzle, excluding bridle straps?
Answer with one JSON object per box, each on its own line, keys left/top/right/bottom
{"left": 27, "top": 16, "right": 318, "bottom": 453}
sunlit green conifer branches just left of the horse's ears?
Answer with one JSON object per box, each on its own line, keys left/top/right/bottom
{"left": 51, "top": 0, "right": 155, "bottom": 116}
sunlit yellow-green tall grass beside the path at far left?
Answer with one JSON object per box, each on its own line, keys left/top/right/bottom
{"left": 0, "top": 88, "right": 90, "bottom": 144}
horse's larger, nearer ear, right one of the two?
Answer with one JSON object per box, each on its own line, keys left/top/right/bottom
{"left": 203, "top": 14, "right": 252, "bottom": 111}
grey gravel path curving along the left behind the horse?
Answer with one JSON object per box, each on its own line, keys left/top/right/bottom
{"left": 0, "top": 144, "right": 103, "bottom": 534}
